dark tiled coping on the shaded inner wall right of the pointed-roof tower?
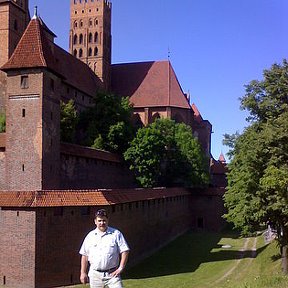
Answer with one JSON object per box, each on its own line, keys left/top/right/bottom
{"left": 60, "top": 143, "right": 121, "bottom": 162}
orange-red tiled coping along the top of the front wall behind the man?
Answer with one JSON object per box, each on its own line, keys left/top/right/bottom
{"left": 0, "top": 188, "right": 191, "bottom": 207}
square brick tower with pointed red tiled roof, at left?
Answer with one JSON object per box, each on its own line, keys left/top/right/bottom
{"left": 1, "top": 15, "right": 63, "bottom": 191}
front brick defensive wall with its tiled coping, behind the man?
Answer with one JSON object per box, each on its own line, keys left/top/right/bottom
{"left": 0, "top": 188, "right": 224, "bottom": 288}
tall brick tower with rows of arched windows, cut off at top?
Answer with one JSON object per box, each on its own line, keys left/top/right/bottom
{"left": 69, "top": 0, "right": 112, "bottom": 89}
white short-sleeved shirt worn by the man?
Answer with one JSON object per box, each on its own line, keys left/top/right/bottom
{"left": 79, "top": 227, "right": 129, "bottom": 270}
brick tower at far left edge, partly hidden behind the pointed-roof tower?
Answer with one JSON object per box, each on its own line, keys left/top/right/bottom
{"left": 0, "top": 0, "right": 30, "bottom": 111}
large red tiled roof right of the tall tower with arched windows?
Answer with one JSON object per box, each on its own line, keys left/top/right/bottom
{"left": 112, "top": 61, "right": 191, "bottom": 109}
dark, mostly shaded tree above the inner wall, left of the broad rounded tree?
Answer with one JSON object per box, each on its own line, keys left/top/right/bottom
{"left": 79, "top": 93, "right": 134, "bottom": 153}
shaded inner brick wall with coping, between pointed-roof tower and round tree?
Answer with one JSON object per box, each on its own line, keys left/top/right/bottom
{"left": 60, "top": 143, "right": 135, "bottom": 189}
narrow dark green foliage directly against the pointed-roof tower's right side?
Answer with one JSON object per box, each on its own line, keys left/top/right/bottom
{"left": 60, "top": 99, "right": 78, "bottom": 142}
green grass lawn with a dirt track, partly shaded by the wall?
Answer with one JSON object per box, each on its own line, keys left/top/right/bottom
{"left": 71, "top": 232, "right": 288, "bottom": 288}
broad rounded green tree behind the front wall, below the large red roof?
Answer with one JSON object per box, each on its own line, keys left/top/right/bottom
{"left": 124, "top": 119, "right": 208, "bottom": 187}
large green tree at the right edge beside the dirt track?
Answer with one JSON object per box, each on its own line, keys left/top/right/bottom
{"left": 224, "top": 60, "right": 288, "bottom": 273}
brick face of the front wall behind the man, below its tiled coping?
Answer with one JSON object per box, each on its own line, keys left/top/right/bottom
{"left": 0, "top": 188, "right": 224, "bottom": 288}
